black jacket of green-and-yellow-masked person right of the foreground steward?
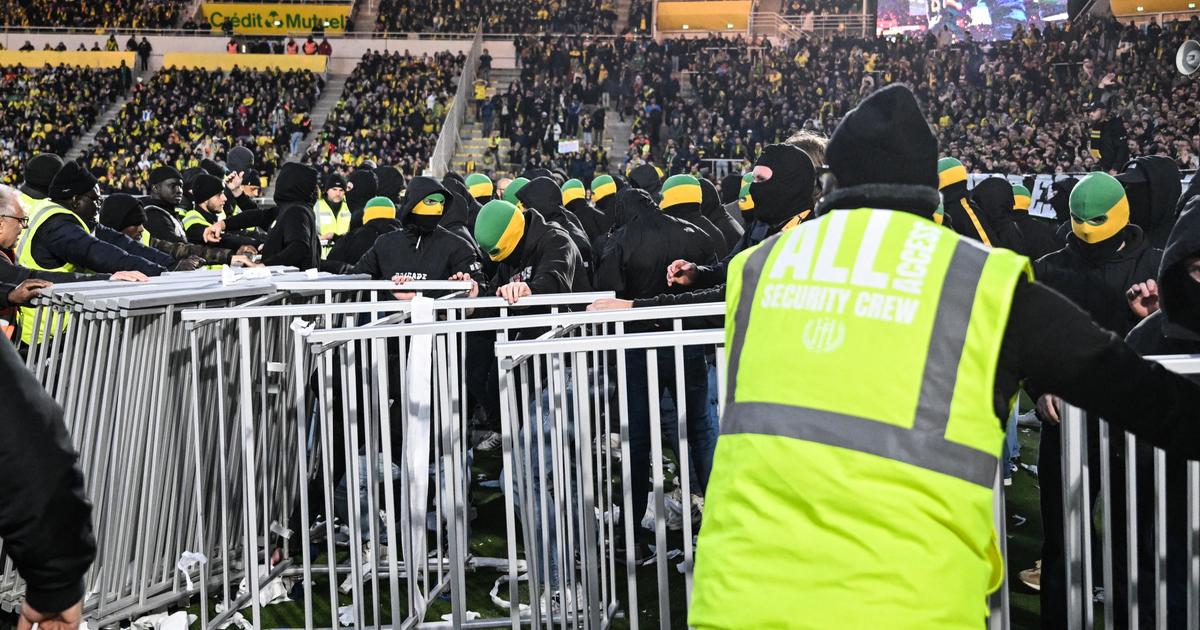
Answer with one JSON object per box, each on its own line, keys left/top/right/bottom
{"left": 1033, "top": 224, "right": 1163, "bottom": 337}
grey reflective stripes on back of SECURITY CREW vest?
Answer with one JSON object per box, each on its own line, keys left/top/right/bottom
{"left": 721, "top": 225, "right": 997, "bottom": 488}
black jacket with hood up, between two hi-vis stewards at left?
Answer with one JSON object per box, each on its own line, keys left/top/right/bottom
{"left": 262, "top": 162, "right": 343, "bottom": 271}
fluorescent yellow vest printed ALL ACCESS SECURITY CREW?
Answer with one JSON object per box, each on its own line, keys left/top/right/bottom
{"left": 689, "top": 209, "right": 1030, "bottom": 630}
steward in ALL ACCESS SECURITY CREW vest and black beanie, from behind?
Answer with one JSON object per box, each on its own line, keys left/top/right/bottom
{"left": 688, "top": 85, "right": 1200, "bottom": 630}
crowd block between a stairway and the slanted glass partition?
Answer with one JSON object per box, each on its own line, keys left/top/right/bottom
{"left": 304, "top": 52, "right": 464, "bottom": 176}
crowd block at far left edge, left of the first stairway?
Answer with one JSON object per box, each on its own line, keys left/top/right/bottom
{"left": 0, "top": 66, "right": 128, "bottom": 184}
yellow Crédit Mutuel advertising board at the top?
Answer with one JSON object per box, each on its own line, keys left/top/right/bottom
{"left": 200, "top": 2, "right": 353, "bottom": 35}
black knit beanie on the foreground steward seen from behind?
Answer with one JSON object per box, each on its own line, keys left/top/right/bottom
{"left": 826, "top": 84, "right": 937, "bottom": 190}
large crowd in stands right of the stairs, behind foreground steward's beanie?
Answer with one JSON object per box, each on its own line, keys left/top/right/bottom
{"left": 623, "top": 20, "right": 1200, "bottom": 173}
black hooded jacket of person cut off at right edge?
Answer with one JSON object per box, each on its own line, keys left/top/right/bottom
{"left": 1127, "top": 199, "right": 1200, "bottom": 355}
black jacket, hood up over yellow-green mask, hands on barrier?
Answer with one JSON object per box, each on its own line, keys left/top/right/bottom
{"left": 354, "top": 178, "right": 480, "bottom": 280}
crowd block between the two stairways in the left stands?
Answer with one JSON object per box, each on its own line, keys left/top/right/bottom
{"left": 83, "top": 68, "right": 323, "bottom": 192}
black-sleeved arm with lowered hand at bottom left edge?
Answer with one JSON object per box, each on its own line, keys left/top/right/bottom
{"left": 0, "top": 335, "right": 96, "bottom": 628}
